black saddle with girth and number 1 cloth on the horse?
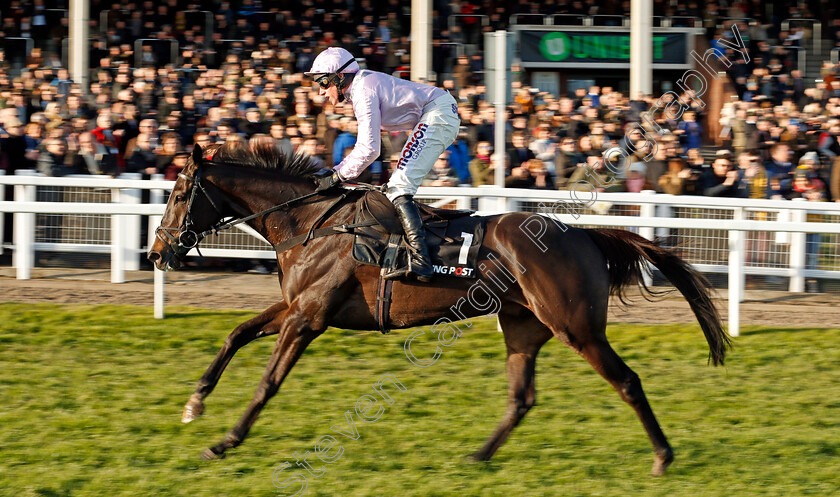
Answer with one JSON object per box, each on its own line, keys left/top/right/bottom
{"left": 353, "top": 191, "right": 484, "bottom": 333}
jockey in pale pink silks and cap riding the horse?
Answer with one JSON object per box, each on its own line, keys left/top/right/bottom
{"left": 305, "top": 47, "right": 461, "bottom": 281}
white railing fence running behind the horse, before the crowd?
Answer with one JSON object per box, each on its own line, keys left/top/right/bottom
{"left": 0, "top": 171, "right": 840, "bottom": 334}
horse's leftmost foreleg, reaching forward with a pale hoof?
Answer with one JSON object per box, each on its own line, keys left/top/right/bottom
{"left": 181, "top": 301, "right": 288, "bottom": 423}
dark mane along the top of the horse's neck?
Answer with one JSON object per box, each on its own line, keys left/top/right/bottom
{"left": 204, "top": 140, "right": 320, "bottom": 178}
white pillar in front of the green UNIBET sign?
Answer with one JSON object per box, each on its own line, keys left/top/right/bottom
{"left": 630, "top": 0, "right": 653, "bottom": 99}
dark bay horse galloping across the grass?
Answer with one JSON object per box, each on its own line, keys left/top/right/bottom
{"left": 148, "top": 141, "right": 729, "bottom": 474}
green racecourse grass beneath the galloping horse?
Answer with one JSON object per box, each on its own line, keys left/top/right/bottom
{"left": 0, "top": 304, "right": 840, "bottom": 497}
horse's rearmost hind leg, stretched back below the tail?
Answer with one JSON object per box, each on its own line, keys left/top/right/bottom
{"left": 579, "top": 337, "right": 674, "bottom": 475}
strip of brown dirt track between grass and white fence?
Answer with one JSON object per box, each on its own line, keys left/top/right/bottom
{"left": 0, "top": 267, "right": 840, "bottom": 328}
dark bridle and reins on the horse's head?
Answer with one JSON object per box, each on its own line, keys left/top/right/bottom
{"left": 155, "top": 161, "right": 319, "bottom": 259}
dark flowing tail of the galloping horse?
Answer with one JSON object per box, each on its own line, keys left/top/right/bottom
{"left": 586, "top": 229, "right": 731, "bottom": 366}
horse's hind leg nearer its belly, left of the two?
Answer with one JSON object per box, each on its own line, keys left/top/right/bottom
{"left": 472, "top": 307, "right": 552, "bottom": 461}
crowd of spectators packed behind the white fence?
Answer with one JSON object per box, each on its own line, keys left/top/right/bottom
{"left": 0, "top": 0, "right": 840, "bottom": 207}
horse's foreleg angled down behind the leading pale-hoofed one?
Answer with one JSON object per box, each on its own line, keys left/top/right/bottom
{"left": 202, "top": 304, "right": 321, "bottom": 459}
